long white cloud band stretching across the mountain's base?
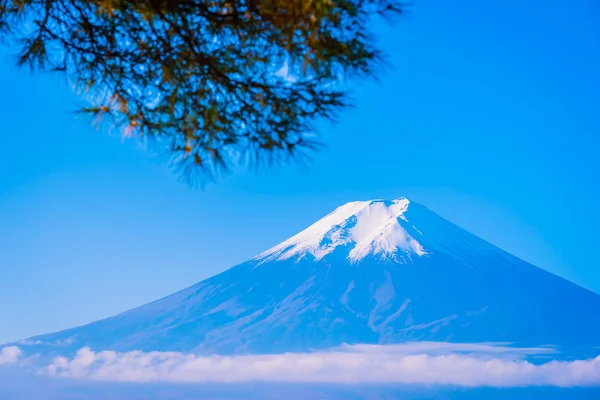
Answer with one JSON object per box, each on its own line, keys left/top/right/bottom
{"left": 44, "top": 342, "right": 600, "bottom": 387}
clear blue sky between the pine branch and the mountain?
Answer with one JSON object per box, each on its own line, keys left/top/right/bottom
{"left": 0, "top": 0, "right": 600, "bottom": 343}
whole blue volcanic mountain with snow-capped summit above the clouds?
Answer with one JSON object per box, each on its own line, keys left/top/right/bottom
{"left": 17, "top": 198, "right": 600, "bottom": 354}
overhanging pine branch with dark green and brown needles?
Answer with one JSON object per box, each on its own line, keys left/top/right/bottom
{"left": 0, "top": 0, "right": 401, "bottom": 183}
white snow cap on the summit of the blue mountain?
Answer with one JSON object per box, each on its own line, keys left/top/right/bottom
{"left": 255, "top": 197, "right": 426, "bottom": 262}
